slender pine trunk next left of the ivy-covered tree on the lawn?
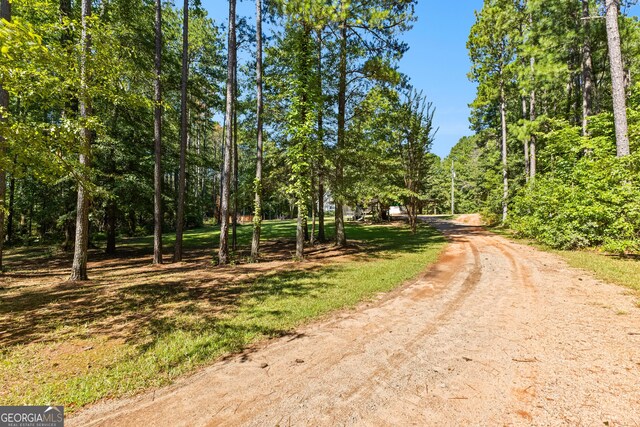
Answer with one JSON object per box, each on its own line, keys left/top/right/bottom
{"left": 251, "top": 0, "right": 263, "bottom": 259}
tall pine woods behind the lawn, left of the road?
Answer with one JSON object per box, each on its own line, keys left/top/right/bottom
{"left": 0, "top": 0, "right": 436, "bottom": 280}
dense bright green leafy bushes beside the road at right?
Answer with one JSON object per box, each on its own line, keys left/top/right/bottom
{"left": 510, "top": 115, "right": 640, "bottom": 252}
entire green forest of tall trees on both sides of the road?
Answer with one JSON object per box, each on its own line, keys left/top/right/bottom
{"left": 0, "top": 0, "right": 640, "bottom": 280}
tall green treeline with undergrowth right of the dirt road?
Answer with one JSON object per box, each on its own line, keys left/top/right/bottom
{"left": 450, "top": 0, "right": 640, "bottom": 252}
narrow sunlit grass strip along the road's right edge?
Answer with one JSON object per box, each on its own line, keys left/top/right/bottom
{"left": 489, "top": 227, "right": 640, "bottom": 294}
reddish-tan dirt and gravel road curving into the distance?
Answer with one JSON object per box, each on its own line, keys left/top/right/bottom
{"left": 68, "top": 220, "right": 640, "bottom": 426}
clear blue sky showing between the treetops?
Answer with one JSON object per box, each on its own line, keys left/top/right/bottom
{"left": 202, "top": 0, "right": 640, "bottom": 157}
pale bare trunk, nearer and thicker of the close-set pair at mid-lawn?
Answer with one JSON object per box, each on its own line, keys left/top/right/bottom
{"left": 218, "top": 0, "right": 236, "bottom": 265}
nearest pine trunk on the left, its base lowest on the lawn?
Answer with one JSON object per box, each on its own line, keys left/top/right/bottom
{"left": 69, "top": 0, "right": 93, "bottom": 281}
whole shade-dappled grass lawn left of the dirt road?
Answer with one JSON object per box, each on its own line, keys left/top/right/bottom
{"left": 0, "top": 221, "right": 445, "bottom": 412}
